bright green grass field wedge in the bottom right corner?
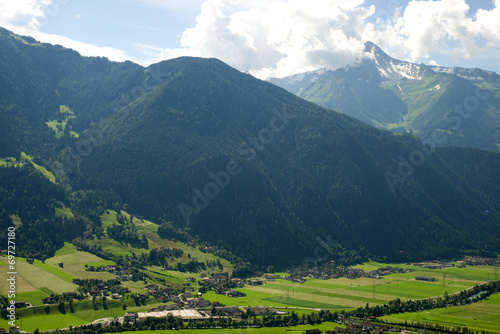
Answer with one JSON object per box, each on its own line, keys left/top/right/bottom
{"left": 383, "top": 294, "right": 500, "bottom": 333}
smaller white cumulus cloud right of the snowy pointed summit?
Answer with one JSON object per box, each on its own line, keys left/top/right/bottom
{"left": 366, "top": 0, "right": 500, "bottom": 61}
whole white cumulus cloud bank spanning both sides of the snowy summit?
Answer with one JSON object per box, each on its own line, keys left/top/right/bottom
{"left": 155, "top": 0, "right": 500, "bottom": 78}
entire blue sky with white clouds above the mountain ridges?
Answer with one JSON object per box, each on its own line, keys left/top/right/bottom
{"left": 0, "top": 0, "right": 500, "bottom": 79}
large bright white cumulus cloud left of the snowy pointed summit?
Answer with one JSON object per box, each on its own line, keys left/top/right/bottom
{"left": 161, "top": 0, "right": 374, "bottom": 77}
